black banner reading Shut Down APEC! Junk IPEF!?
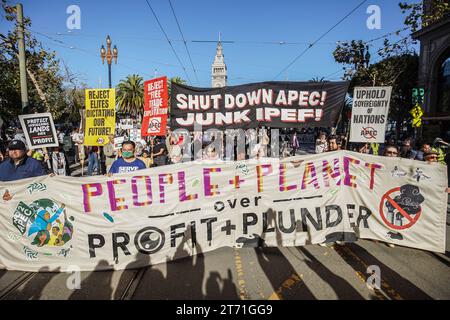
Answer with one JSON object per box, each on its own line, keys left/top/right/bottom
{"left": 170, "top": 81, "right": 348, "bottom": 130}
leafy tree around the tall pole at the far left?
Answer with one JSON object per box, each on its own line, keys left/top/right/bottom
{"left": 0, "top": 0, "right": 79, "bottom": 121}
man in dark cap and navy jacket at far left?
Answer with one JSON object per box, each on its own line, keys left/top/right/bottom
{"left": 0, "top": 140, "right": 46, "bottom": 181}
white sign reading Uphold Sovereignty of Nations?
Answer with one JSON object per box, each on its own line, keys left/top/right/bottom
{"left": 350, "top": 87, "right": 392, "bottom": 143}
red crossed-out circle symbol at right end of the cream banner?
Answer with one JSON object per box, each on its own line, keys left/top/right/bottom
{"left": 380, "top": 187, "right": 423, "bottom": 230}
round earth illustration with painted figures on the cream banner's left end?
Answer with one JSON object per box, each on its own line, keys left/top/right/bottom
{"left": 9, "top": 198, "right": 74, "bottom": 260}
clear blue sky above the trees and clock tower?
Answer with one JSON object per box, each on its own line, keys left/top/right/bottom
{"left": 0, "top": 0, "right": 418, "bottom": 87}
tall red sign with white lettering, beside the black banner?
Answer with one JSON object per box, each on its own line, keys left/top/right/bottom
{"left": 141, "top": 77, "right": 169, "bottom": 137}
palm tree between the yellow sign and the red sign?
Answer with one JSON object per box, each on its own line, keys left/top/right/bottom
{"left": 116, "top": 74, "right": 144, "bottom": 117}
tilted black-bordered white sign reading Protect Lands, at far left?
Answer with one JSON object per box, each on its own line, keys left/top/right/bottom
{"left": 19, "top": 113, "right": 59, "bottom": 149}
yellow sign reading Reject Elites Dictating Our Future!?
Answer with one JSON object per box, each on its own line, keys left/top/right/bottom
{"left": 84, "top": 89, "right": 116, "bottom": 146}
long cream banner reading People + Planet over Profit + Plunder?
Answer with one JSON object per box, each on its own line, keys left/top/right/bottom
{"left": 0, "top": 151, "right": 447, "bottom": 271}
